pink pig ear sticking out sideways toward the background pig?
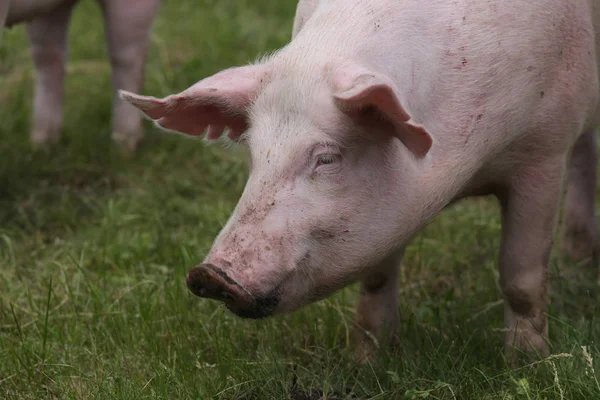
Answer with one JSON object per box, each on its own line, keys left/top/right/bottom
{"left": 119, "top": 65, "right": 266, "bottom": 140}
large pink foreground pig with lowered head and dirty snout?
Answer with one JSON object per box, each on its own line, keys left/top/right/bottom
{"left": 122, "top": 0, "right": 599, "bottom": 362}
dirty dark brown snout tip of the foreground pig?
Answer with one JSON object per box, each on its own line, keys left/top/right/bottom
{"left": 186, "top": 264, "right": 279, "bottom": 319}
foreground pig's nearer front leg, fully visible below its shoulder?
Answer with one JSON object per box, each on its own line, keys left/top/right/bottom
{"left": 499, "top": 155, "right": 566, "bottom": 364}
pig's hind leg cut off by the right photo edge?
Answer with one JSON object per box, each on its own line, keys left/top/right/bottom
{"left": 562, "top": 129, "right": 598, "bottom": 264}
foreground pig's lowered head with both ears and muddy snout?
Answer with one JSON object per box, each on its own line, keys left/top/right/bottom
{"left": 121, "top": 60, "right": 432, "bottom": 318}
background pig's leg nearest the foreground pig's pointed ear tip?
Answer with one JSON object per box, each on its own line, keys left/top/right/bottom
{"left": 100, "top": 0, "right": 161, "bottom": 150}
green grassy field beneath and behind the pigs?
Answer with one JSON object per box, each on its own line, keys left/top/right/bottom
{"left": 0, "top": 0, "right": 600, "bottom": 400}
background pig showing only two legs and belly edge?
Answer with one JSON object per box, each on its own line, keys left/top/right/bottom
{"left": 0, "top": 0, "right": 162, "bottom": 150}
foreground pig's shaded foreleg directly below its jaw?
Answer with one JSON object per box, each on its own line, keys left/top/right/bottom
{"left": 355, "top": 249, "right": 404, "bottom": 360}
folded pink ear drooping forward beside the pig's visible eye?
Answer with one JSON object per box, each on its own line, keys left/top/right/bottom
{"left": 333, "top": 70, "right": 433, "bottom": 157}
